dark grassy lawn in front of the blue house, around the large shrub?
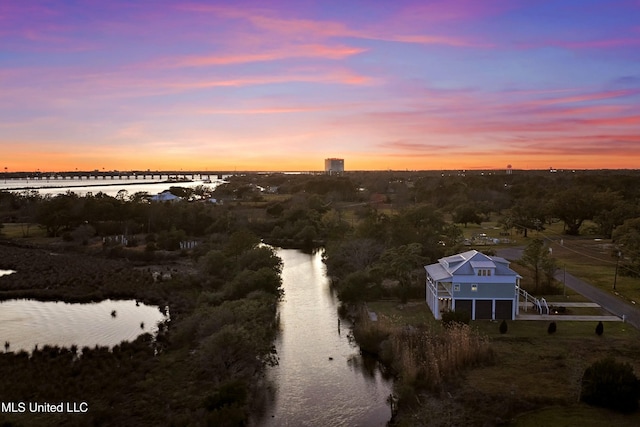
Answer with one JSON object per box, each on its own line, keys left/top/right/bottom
{"left": 466, "top": 321, "right": 640, "bottom": 426}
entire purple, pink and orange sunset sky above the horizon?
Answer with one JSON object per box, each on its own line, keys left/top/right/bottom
{"left": 0, "top": 0, "right": 640, "bottom": 171}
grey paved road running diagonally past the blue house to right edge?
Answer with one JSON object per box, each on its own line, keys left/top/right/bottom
{"left": 497, "top": 248, "right": 640, "bottom": 329}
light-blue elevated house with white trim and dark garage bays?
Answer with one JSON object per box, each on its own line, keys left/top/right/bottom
{"left": 424, "top": 250, "right": 522, "bottom": 320}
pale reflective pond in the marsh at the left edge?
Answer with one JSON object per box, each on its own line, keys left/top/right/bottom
{"left": 0, "top": 299, "right": 167, "bottom": 352}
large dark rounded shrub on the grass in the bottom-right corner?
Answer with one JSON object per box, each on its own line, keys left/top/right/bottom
{"left": 580, "top": 357, "right": 640, "bottom": 413}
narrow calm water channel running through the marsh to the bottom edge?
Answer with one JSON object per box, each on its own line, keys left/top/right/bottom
{"left": 259, "top": 250, "right": 392, "bottom": 427}
